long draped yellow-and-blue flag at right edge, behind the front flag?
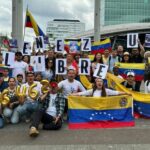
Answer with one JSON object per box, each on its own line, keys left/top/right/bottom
{"left": 107, "top": 73, "right": 150, "bottom": 118}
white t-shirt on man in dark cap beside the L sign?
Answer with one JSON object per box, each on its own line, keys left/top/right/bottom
{"left": 12, "top": 61, "right": 28, "bottom": 82}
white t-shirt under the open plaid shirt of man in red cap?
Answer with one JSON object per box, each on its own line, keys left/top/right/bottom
{"left": 46, "top": 94, "right": 57, "bottom": 117}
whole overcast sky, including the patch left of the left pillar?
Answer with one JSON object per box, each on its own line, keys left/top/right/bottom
{"left": 0, "top": 0, "right": 94, "bottom": 38}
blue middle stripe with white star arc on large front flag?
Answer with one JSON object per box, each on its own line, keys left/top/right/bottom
{"left": 69, "top": 108, "right": 133, "bottom": 123}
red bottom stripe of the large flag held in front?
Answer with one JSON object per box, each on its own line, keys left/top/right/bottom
{"left": 69, "top": 121, "right": 135, "bottom": 129}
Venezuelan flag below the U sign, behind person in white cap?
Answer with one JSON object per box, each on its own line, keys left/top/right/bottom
{"left": 116, "top": 63, "right": 145, "bottom": 81}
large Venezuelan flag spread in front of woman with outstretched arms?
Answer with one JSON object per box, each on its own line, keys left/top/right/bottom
{"left": 68, "top": 96, "right": 134, "bottom": 129}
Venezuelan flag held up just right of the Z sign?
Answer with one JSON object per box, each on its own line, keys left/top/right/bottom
{"left": 91, "top": 39, "right": 111, "bottom": 54}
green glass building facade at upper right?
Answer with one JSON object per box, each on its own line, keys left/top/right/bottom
{"left": 101, "top": 0, "right": 150, "bottom": 25}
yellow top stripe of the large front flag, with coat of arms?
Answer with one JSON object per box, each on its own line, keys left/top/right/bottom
{"left": 68, "top": 95, "right": 132, "bottom": 110}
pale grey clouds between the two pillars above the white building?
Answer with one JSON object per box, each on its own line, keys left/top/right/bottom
{"left": 24, "top": 0, "right": 94, "bottom": 29}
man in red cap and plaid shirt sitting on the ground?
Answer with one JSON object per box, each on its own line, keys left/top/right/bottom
{"left": 29, "top": 82, "right": 65, "bottom": 136}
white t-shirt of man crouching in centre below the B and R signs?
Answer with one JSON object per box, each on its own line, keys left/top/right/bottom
{"left": 58, "top": 79, "right": 85, "bottom": 98}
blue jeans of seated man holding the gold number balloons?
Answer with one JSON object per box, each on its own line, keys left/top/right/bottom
{"left": 11, "top": 101, "right": 39, "bottom": 124}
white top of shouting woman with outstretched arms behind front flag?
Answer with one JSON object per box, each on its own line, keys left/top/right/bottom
{"left": 78, "top": 89, "right": 119, "bottom": 97}
